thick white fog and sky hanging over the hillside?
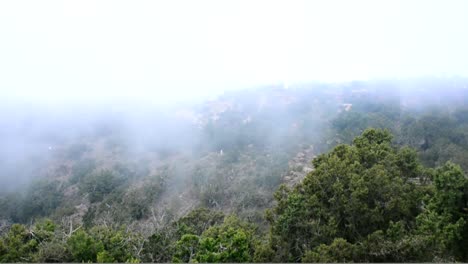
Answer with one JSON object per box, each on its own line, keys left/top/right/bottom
{"left": 0, "top": 0, "right": 468, "bottom": 193}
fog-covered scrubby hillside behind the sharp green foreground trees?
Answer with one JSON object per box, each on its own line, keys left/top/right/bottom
{"left": 0, "top": 79, "right": 468, "bottom": 261}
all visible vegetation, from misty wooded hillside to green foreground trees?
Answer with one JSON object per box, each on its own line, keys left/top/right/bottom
{"left": 0, "top": 81, "right": 468, "bottom": 262}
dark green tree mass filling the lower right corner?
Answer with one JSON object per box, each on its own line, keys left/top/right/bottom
{"left": 259, "top": 129, "right": 468, "bottom": 262}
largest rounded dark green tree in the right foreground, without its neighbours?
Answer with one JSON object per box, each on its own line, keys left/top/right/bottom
{"left": 267, "top": 129, "right": 422, "bottom": 262}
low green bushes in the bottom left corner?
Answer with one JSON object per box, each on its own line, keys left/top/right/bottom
{"left": 0, "top": 220, "right": 142, "bottom": 263}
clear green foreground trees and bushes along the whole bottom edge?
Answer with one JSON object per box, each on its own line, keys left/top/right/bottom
{"left": 0, "top": 129, "right": 468, "bottom": 262}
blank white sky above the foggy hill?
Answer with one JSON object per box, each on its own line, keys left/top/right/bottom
{"left": 0, "top": 0, "right": 468, "bottom": 102}
